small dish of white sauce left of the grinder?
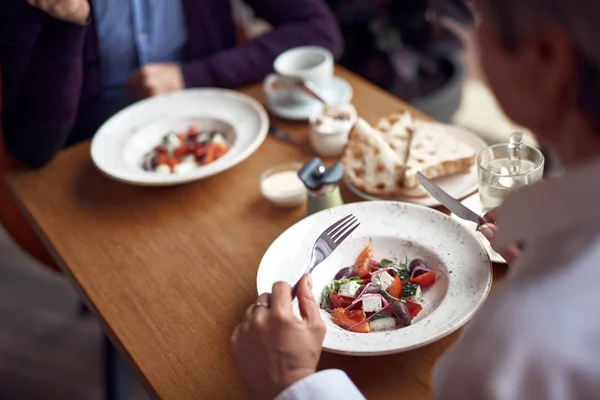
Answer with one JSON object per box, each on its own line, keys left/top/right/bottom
{"left": 260, "top": 163, "right": 306, "bottom": 208}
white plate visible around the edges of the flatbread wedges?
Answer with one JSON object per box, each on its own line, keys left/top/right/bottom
{"left": 344, "top": 125, "right": 488, "bottom": 207}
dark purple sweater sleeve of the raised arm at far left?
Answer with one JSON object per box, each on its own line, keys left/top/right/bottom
{"left": 0, "top": 5, "right": 86, "bottom": 167}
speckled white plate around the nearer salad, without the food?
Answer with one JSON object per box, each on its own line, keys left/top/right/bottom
{"left": 256, "top": 201, "right": 492, "bottom": 356}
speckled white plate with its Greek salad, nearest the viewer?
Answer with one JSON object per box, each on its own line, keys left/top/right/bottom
{"left": 257, "top": 201, "right": 492, "bottom": 356}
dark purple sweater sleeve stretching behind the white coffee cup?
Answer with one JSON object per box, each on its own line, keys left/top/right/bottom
{"left": 182, "top": 0, "right": 342, "bottom": 88}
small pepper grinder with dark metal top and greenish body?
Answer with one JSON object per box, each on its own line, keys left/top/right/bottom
{"left": 298, "top": 158, "right": 344, "bottom": 216}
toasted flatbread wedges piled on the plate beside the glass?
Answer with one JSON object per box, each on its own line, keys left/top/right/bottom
{"left": 342, "top": 112, "right": 477, "bottom": 197}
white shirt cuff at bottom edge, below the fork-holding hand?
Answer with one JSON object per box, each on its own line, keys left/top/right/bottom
{"left": 275, "top": 369, "right": 365, "bottom": 400}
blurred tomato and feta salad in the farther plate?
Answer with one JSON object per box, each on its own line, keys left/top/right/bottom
{"left": 142, "top": 125, "right": 230, "bottom": 174}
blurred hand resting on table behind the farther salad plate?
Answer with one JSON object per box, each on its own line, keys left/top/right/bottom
{"left": 126, "top": 63, "right": 185, "bottom": 99}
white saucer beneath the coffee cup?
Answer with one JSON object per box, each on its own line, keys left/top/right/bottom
{"left": 267, "top": 76, "right": 353, "bottom": 121}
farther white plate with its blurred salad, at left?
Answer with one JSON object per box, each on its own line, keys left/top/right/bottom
{"left": 91, "top": 88, "right": 269, "bottom": 186}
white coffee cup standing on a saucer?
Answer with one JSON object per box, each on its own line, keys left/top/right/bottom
{"left": 273, "top": 46, "right": 333, "bottom": 90}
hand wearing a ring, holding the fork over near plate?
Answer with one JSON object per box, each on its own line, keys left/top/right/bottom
{"left": 231, "top": 276, "right": 325, "bottom": 399}
